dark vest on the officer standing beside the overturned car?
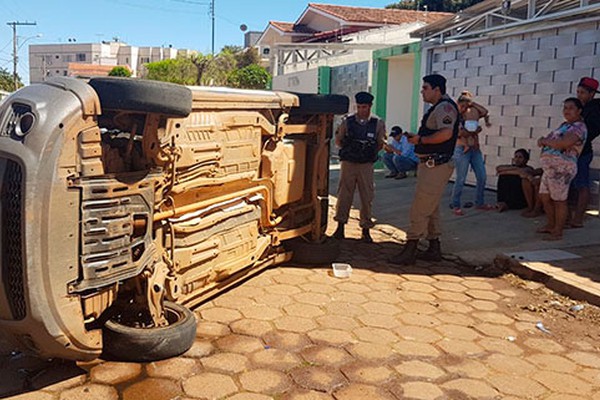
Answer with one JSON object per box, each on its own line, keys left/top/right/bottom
{"left": 340, "top": 115, "right": 379, "bottom": 164}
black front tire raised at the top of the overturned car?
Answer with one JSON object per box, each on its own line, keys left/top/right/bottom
{"left": 89, "top": 77, "right": 192, "bottom": 117}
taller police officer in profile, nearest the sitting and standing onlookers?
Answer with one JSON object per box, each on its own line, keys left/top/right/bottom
{"left": 390, "top": 74, "right": 459, "bottom": 265}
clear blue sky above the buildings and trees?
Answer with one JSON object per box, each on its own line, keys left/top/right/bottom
{"left": 0, "top": 0, "right": 395, "bottom": 83}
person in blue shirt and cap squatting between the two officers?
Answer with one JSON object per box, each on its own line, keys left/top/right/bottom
{"left": 382, "top": 126, "right": 419, "bottom": 179}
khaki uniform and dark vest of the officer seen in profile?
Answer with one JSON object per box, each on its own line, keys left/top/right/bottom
{"left": 406, "top": 94, "right": 459, "bottom": 240}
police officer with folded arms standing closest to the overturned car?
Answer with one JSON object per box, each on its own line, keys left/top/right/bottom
{"left": 333, "top": 92, "right": 385, "bottom": 243}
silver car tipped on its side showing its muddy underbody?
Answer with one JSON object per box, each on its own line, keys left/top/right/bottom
{"left": 0, "top": 78, "right": 348, "bottom": 361}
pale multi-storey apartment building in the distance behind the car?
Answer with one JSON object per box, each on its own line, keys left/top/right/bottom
{"left": 29, "top": 41, "right": 193, "bottom": 83}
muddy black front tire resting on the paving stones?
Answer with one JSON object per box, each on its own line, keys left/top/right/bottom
{"left": 102, "top": 301, "right": 196, "bottom": 362}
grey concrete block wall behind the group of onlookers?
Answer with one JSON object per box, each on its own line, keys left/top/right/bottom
{"left": 425, "top": 22, "right": 600, "bottom": 187}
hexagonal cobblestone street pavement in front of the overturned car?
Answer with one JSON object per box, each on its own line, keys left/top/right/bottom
{"left": 0, "top": 223, "right": 600, "bottom": 400}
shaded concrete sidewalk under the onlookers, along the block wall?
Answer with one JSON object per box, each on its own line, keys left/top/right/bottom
{"left": 329, "top": 168, "right": 600, "bottom": 305}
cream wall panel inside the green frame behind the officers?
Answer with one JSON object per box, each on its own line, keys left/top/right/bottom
{"left": 386, "top": 54, "right": 414, "bottom": 130}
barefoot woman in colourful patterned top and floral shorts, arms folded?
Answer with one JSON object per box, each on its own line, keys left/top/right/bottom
{"left": 537, "top": 97, "right": 587, "bottom": 240}
